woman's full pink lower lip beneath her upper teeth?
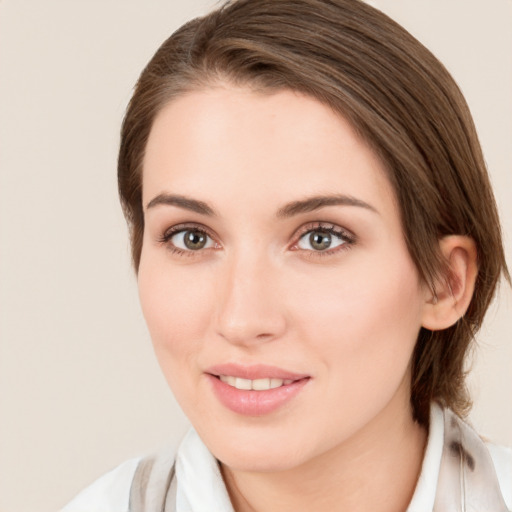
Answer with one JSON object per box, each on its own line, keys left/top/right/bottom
{"left": 207, "top": 375, "right": 309, "bottom": 416}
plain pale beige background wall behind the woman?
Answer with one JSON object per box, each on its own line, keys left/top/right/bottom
{"left": 0, "top": 0, "right": 512, "bottom": 512}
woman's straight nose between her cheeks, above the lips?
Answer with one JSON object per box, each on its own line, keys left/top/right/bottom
{"left": 215, "top": 253, "right": 286, "bottom": 346}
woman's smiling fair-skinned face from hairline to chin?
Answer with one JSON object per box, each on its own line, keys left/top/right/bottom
{"left": 138, "top": 85, "right": 426, "bottom": 471}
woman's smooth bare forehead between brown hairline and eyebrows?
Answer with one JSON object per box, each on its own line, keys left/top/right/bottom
{"left": 143, "top": 85, "right": 394, "bottom": 216}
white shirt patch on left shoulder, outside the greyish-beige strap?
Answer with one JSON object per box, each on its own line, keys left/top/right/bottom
{"left": 60, "top": 458, "right": 141, "bottom": 512}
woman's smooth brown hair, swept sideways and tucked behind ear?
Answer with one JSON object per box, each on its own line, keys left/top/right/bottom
{"left": 118, "top": 0, "right": 510, "bottom": 425}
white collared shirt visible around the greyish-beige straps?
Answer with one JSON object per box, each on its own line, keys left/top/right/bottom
{"left": 61, "top": 405, "right": 512, "bottom": 512}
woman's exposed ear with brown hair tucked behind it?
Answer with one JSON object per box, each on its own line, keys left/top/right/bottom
{"left": 422, "top": 235, "right": 478, "bottom": 331}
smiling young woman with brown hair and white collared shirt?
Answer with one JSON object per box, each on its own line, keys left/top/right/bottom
{"left": 65, "top": 0, "right": 512, "bottom": 512}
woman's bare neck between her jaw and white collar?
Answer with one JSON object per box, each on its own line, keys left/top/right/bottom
{"left": 221, "top": 382, "right": 427, "bottom": 512}
